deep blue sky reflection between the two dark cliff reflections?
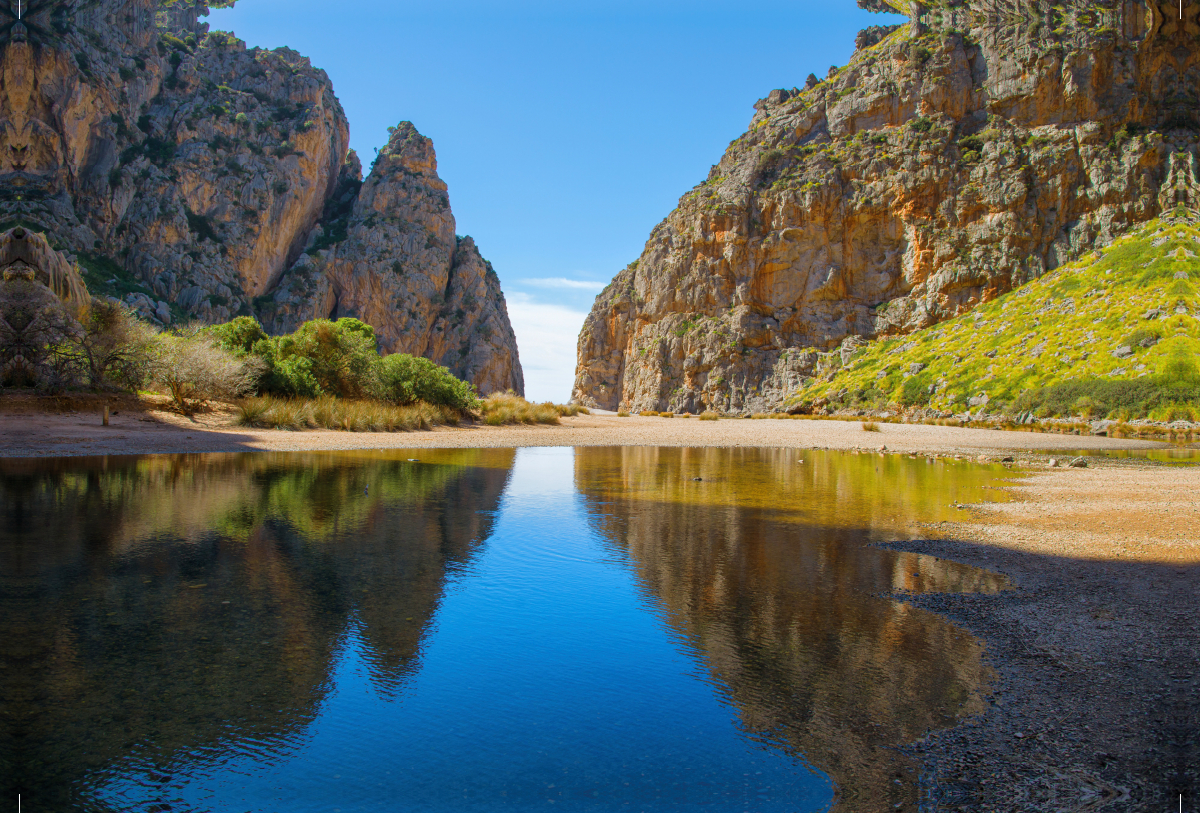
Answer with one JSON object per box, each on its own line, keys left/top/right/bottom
{"left": 98, "top": 448, "right": 832, "bottom": 812}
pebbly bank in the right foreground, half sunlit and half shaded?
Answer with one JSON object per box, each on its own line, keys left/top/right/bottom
{"left": 896, "top": 466, "right": 1200, "bottom": 813}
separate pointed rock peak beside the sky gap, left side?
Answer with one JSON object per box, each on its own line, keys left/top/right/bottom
{"left": 262, "top": 121, "right": 524, "bottom": 392}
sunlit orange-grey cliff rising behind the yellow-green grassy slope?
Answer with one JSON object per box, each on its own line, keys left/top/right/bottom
{"left": 575, "top": 0, "right": 1200, "bottom": 411}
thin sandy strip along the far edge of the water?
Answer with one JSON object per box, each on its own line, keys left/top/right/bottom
{"left": 0, "top": 411, "right": 1180, "bottom": 457}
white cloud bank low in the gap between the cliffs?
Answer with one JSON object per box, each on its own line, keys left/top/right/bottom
{"left": 505, "top": 293, "right": 587, "bottom": 404}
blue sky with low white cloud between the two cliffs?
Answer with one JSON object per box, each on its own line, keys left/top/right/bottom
{"left": 208, "top": 0, "right": 900, "bottom": 402}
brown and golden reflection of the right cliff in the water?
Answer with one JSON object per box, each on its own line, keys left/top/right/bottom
{"left": 576, "top": 448, "right": 1003, "bottom": 812}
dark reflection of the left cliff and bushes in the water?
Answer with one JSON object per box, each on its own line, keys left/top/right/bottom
{"left": 0, "top": 450, "right": 512, "bottom": 809}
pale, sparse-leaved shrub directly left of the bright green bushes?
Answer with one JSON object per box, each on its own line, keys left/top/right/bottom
{"left": 154, "top": 330, "right": 262, "bottom": 414}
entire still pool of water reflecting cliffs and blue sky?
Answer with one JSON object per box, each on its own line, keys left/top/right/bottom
{"left": 0, "top": 448, "right": 1007, "bottom": 813}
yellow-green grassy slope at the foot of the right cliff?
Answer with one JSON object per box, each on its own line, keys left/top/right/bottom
{"left": 788, "top": 221, "right": 1200, "bottom": 420}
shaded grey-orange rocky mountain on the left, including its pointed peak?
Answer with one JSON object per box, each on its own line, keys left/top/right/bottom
{"left": 0, "top": 0, "right": 523, "bottom": 392}
